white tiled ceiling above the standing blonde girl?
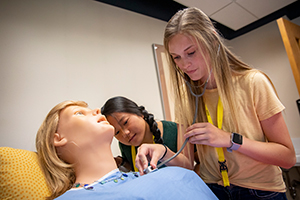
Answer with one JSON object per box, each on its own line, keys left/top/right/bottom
{"left": 174, "top": 0, "right": 300, "bottom": 31}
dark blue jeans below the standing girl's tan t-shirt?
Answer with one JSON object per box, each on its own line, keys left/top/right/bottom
{"left": 207, "top": 184, "right": 287, "bottom": 200}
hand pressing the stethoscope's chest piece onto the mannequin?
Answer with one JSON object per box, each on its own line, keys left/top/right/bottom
{"left": 135, "top": 144, "right": 166, "bottom": 175}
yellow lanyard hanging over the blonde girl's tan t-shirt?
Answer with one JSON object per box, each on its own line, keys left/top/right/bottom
{"left": 205, "top": 98, "right": 230, "bottom": 187}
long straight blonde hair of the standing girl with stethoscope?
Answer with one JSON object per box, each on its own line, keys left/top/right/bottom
{"left": 164, "top": 7, "right": 252, "bottom": 158}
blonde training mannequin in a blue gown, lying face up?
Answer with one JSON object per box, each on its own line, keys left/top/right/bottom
{"left": 36, "top": 101, "right": 217, "bottom": 199}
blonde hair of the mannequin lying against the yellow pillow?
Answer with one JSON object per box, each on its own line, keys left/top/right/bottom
{"left": 36, "top": 101, "right": 88, "bottom": 199}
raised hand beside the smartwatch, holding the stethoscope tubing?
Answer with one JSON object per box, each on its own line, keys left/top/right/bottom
{"left": 184, "top": 122, "right": 231, "bottom": 147}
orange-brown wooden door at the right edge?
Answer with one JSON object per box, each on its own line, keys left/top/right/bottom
{"left": 277, "top": 18, "right": 300, "bottom": 95}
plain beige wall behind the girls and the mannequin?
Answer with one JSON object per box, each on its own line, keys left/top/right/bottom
{"left": 0, "top": 0, "right": 300, "bottom": 155}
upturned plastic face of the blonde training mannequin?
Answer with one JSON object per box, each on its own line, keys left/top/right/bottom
{"left": 54, "top": 106, "right": 114, "bottom": 162}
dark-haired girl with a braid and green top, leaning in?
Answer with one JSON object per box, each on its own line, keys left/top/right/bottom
{"left": 101, "top": 96, "right": 192, "bottom": 171}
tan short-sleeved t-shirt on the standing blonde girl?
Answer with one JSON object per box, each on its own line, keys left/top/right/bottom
{"left": 197, "top": 70, "right": 285, "bottom": 192}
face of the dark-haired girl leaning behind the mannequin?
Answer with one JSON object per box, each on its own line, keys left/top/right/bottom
{"left": 107, "top": 112, "right": 146, "bottom": 146}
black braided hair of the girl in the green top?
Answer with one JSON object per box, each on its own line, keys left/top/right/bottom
{"left": 101, "top": 96, "right": 163, "bottom": 144}
